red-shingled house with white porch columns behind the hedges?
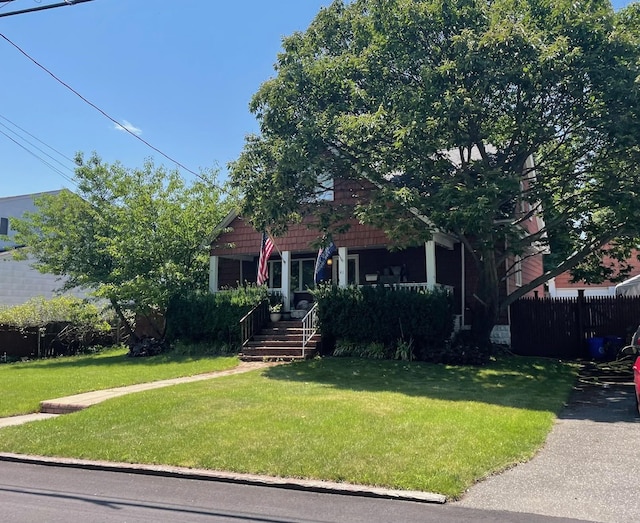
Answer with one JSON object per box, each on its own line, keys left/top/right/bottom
{"left": 209, "top": 174, "right": 543, "bottom": 344}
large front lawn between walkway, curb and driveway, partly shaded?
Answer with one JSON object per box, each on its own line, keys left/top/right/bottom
{"left": 0, "top": 357, "right": 576, "bottom": 498}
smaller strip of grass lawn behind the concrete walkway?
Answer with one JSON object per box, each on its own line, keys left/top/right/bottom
{"left": 0, "top": 348, "right": 238, "bottom": 417}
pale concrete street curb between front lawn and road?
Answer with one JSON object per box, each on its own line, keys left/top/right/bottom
{"left": 0, "top": 452, "right": 447, "bottom": 504}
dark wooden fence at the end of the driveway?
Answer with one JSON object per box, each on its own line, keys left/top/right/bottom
{"left": 510, "top": 296, "right": 640, "bottom": 359}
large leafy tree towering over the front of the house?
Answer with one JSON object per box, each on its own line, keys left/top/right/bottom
{"left": 231, "top": 0, "right": 640, "bottom": 341}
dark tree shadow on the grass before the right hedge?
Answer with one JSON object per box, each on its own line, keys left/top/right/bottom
{"left": 263, "top": 356, "right": 577, "bottom": 414}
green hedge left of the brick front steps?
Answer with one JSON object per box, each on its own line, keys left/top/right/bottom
{"left": 166, "top": 286, "right": 267, "bottom": 346}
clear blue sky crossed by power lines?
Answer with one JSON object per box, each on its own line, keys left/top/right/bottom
{"left": 0, "top": 0, "right": 630, "bottom": 197}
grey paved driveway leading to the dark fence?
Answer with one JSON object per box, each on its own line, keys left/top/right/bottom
{"left": 455, "top": 367, "right": 640, "bottom": 523}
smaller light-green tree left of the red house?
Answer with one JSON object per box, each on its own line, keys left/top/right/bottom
{"left": 12, "top": 154, "right": 228, "bottom": 336}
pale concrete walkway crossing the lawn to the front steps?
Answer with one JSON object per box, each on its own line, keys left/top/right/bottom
{"left": 0, "top": 362, "right": 280, "bottom": 428}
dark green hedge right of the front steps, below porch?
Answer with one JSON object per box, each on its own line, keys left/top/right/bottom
{"left": 315, "top": 286, "right": 453, "bottom": 361}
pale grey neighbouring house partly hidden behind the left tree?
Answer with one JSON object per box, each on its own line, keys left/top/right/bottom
{"left": 0, "top": 191, "right": 86, "bottom": 307}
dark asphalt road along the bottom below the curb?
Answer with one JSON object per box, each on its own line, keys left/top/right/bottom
{"left": 0, "top": 462, "right": 592, "bottom": 523}
